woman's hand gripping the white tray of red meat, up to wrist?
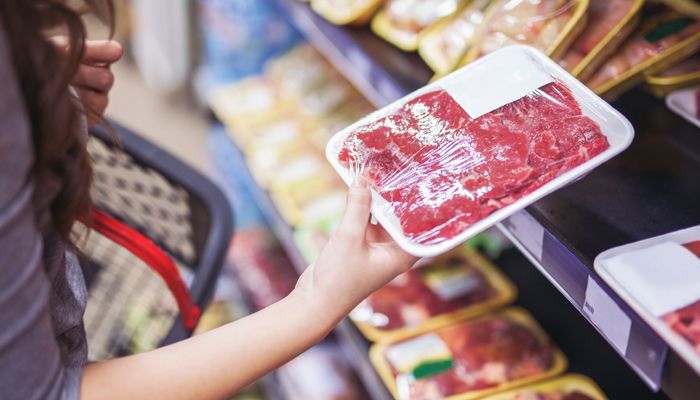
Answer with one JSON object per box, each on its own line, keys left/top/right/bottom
{"left": 295, "top": 178, "right": 417, "bottom": 322}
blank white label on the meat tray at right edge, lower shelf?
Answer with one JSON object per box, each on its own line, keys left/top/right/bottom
{"left": 603, "top": 242, "right": 700, "bottom": 317}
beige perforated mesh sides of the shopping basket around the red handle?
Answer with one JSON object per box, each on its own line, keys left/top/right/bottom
{"left": 82, "top": 137, "right": 196, "bottom": 360}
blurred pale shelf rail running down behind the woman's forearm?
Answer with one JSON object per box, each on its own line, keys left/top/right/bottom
{"left": 219, "top": 127, "right": 391, "bottom": 400}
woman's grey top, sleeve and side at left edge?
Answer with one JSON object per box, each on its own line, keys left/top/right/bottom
{"left": 0, "top": 18, "right": 87, "bottom": 400}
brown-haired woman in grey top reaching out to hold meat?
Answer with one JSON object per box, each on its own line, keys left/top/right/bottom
{"left": 0, "top": 0, "right": 415, "bottom": 399}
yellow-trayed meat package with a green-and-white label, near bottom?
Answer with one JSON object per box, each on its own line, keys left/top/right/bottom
{"left": 370, "top": 309, "right": 566, "bottom": 400}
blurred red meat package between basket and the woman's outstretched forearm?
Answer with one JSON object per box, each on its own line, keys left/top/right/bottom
{"left": 228, "top": 226, "right": 298, "bottom": 309}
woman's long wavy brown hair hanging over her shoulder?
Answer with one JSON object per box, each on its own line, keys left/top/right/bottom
{"left": 0, "top": 0, "right": 114, "bottom": 243}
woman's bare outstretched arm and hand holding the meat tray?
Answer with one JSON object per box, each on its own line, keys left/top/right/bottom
{"left": 82, "top": 180, "right": 415, "bottom": 399}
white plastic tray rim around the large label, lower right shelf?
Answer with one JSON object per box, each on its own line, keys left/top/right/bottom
{"left": 593, "top": 226, "right": 700, "bottom": 374}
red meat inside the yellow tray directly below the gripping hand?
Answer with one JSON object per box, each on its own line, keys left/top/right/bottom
{"left": 365, "top": 257, "right": 497, "bottom": 330}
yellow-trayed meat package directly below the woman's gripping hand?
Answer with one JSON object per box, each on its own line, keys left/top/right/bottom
{"left": 350, "top": 246, "right": 516, "bottom": 342}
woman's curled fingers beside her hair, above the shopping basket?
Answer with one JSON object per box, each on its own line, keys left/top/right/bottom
{"left": 51, "top": 36, "right": 124, "bottom": 126}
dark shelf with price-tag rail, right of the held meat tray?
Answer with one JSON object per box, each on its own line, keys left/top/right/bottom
{"left": 501, "top": 91, "right": 700, "bottom": 399}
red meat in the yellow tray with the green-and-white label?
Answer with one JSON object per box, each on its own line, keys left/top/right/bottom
{"left": 392, "top": 316, "right": 554, "bottom": 400}
